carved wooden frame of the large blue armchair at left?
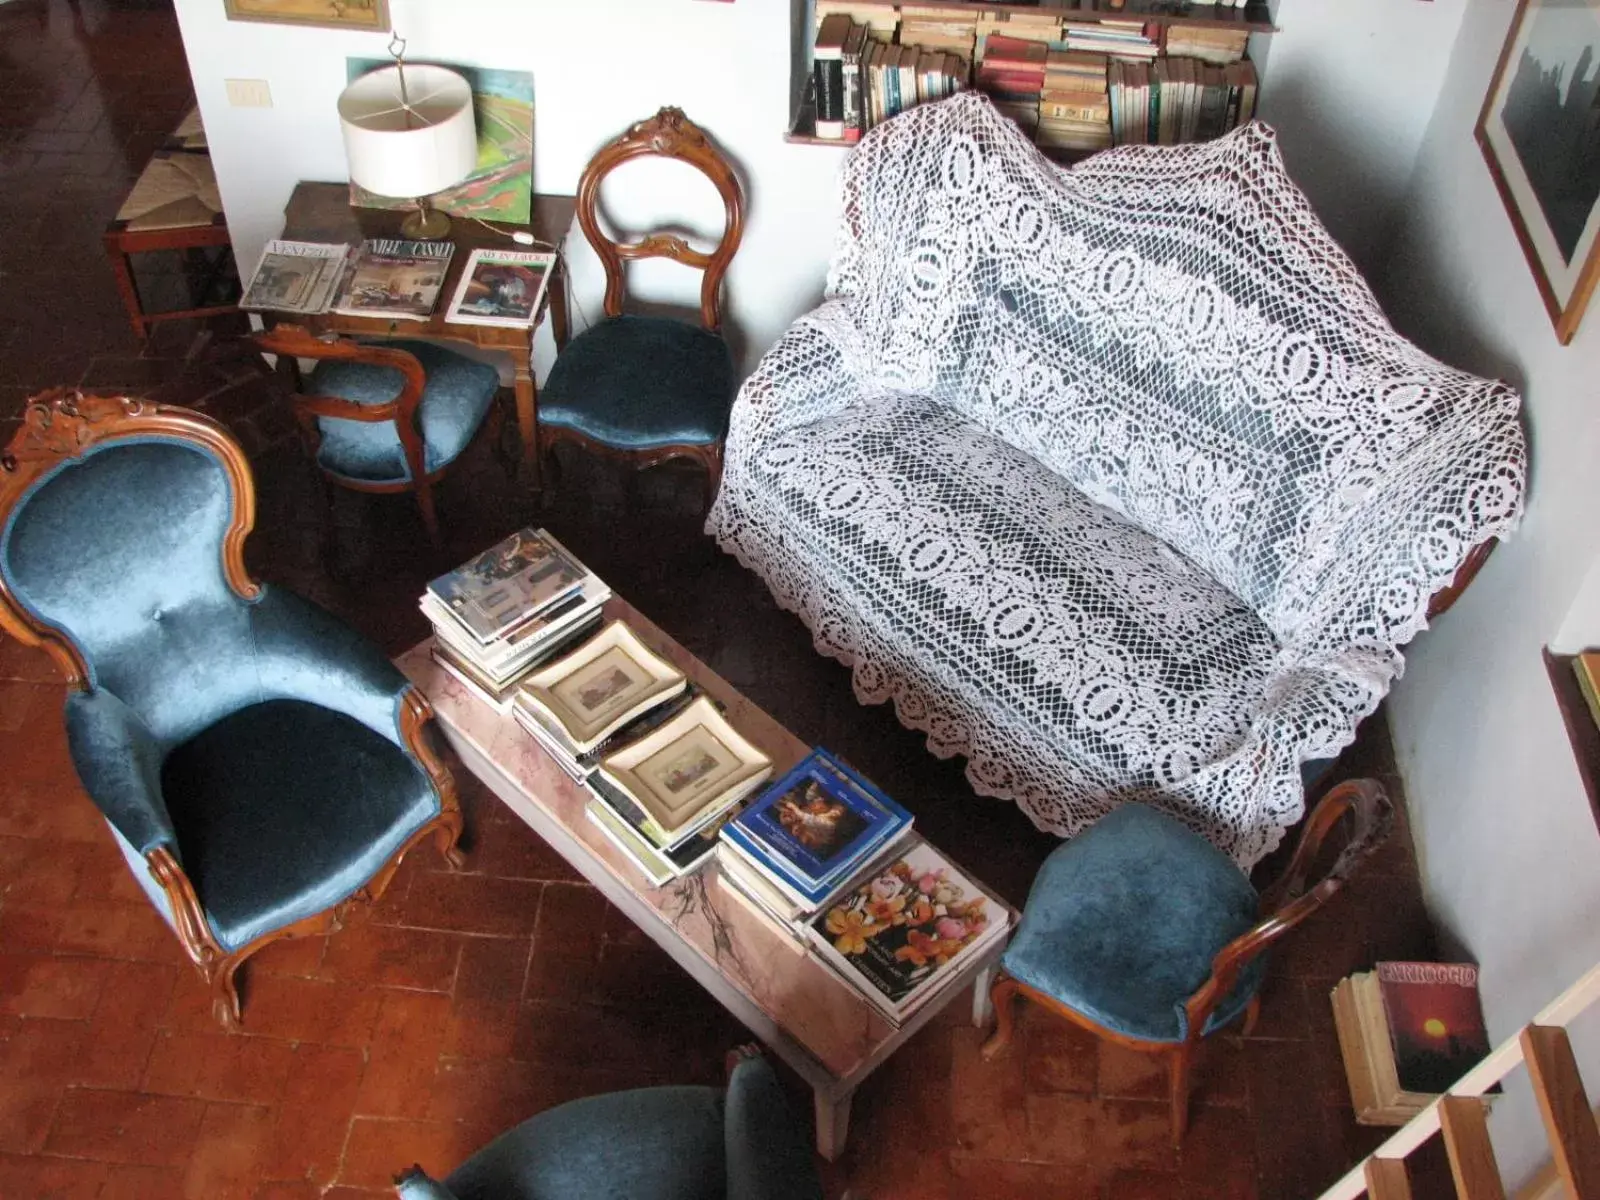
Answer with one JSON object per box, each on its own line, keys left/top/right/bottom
{"left": 0, "top": 389, "right": 462, "bottom": 1029}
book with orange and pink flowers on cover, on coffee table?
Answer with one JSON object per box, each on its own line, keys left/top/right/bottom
{"left": 811, "top": 842, "right": 1008, "bottom": 1010}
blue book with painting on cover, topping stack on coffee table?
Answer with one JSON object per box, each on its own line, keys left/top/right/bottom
{"left": 738, "top": 747, "right": 912, "bottom": 885}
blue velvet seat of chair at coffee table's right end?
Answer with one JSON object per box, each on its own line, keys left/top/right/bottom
{"left": 1002, "top": 803, "right": 1266, "bottom": 1042}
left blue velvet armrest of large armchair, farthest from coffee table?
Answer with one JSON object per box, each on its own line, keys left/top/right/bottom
{"left": 67, "top": 688, "right": 178, "bottom": 856}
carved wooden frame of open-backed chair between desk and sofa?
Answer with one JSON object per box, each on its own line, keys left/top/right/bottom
{"left": 541, "top": 107, "right": 744, "bottom": 496}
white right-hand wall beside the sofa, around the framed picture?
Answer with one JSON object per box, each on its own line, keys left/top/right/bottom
{"left": 1384, "top": 0, "right": 1600, "bottom": 1184}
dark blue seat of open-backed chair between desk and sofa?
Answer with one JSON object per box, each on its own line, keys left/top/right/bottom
{"left": 539, "top": 317, "right": 733, "bottom": 450}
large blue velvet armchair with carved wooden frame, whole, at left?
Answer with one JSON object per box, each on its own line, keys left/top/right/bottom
{"left": 0, "top": 390, "right": 461, "bottom": 1027}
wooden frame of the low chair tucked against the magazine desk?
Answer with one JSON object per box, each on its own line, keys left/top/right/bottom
{"left": 253, "top": 323, "right": 506, "bottom": 546}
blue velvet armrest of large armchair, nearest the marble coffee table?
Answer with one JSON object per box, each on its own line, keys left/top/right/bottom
{"left": 250, "top": 587, "right": 411, "bottom": 747}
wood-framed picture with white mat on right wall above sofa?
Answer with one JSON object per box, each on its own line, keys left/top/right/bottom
{"left": 1477, "top": 0, "right": 1600, "bottom": 346}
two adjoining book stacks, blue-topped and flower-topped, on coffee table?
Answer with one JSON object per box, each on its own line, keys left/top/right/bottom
{"left": 717, "top": 747, "right": 1010, "bottom": 1024}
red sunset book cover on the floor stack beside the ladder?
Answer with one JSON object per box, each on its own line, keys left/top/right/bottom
{"left": 1378, "top": 963, "right": 1490, "bottom": 1094}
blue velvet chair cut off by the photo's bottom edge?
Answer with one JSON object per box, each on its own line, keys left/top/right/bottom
{"left": 395, "top": 1056, "right": 822, "bottom": 1200}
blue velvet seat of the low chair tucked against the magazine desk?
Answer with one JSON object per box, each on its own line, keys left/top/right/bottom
{"left": 306, "top": 341, "right": 499, "bottom": 483}
